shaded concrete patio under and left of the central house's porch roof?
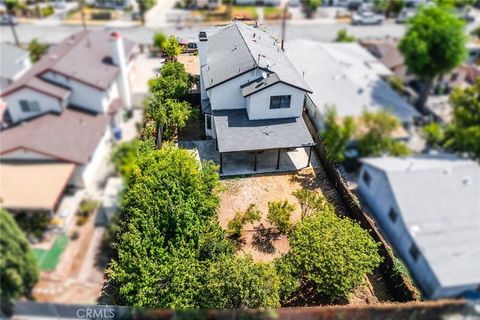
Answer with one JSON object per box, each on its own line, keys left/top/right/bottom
{"left": 179, "top": 140, "right": 319, "bottom": 176}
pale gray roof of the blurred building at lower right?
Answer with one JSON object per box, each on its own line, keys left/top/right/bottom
{"left": 362, "top": 155, "right": 480, "bottom": 286}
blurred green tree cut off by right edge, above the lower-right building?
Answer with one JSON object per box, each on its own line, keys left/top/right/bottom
{"left": 444, "top": 79, "right": 480, "bottom": 159}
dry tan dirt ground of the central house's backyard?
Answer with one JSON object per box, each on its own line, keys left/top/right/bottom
{"left": 218, "top": 167, "right": 393, "bottom": 305}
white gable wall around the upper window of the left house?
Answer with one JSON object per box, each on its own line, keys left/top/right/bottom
{"left": 3, "top": 88, "right": 62, "bottom": 122}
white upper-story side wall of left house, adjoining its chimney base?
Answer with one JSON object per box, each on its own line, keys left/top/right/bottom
{"left": 42, "top": 71, "right": 118, "bottom": 113}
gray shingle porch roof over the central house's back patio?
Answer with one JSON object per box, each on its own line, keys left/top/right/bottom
{"left": 213, "top": 109, "right": 315, "bottom": 153}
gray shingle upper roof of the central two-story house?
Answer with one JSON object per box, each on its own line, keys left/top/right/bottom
{"left": 202, "top": 22, "right": 311, "bottom": 94}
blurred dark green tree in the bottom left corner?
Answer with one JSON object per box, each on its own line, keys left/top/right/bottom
{"left": 0, "top": 209, "right": 39, "bottom": 303}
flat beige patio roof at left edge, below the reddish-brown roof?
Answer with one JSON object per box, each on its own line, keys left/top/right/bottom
{"left": 0, "top": 163, "right": 75, "bottom": 210}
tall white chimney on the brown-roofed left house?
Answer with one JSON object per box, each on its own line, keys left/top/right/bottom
{"left": 110, "top": 32, "right": 132, "bottom": 110}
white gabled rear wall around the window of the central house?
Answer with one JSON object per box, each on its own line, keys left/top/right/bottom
{"left": 247, "top": 83, "right": 305, "bottom": 120}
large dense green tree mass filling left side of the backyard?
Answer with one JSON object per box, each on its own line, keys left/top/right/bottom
{"left": 101, "top": 144, "right": 279, "bottom": 309}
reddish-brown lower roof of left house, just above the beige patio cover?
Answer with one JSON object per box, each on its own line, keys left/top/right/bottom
{"left": 0, "top": 108, "right": 109, "bottom": 164}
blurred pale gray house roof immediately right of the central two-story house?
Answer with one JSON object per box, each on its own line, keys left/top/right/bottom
{"left": 286, "top": 39, "right": 419, "bottom": 130}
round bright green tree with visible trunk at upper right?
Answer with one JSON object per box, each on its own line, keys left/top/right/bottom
{"left": 399, "top": 6, "right": 466, "bottom": 111}
